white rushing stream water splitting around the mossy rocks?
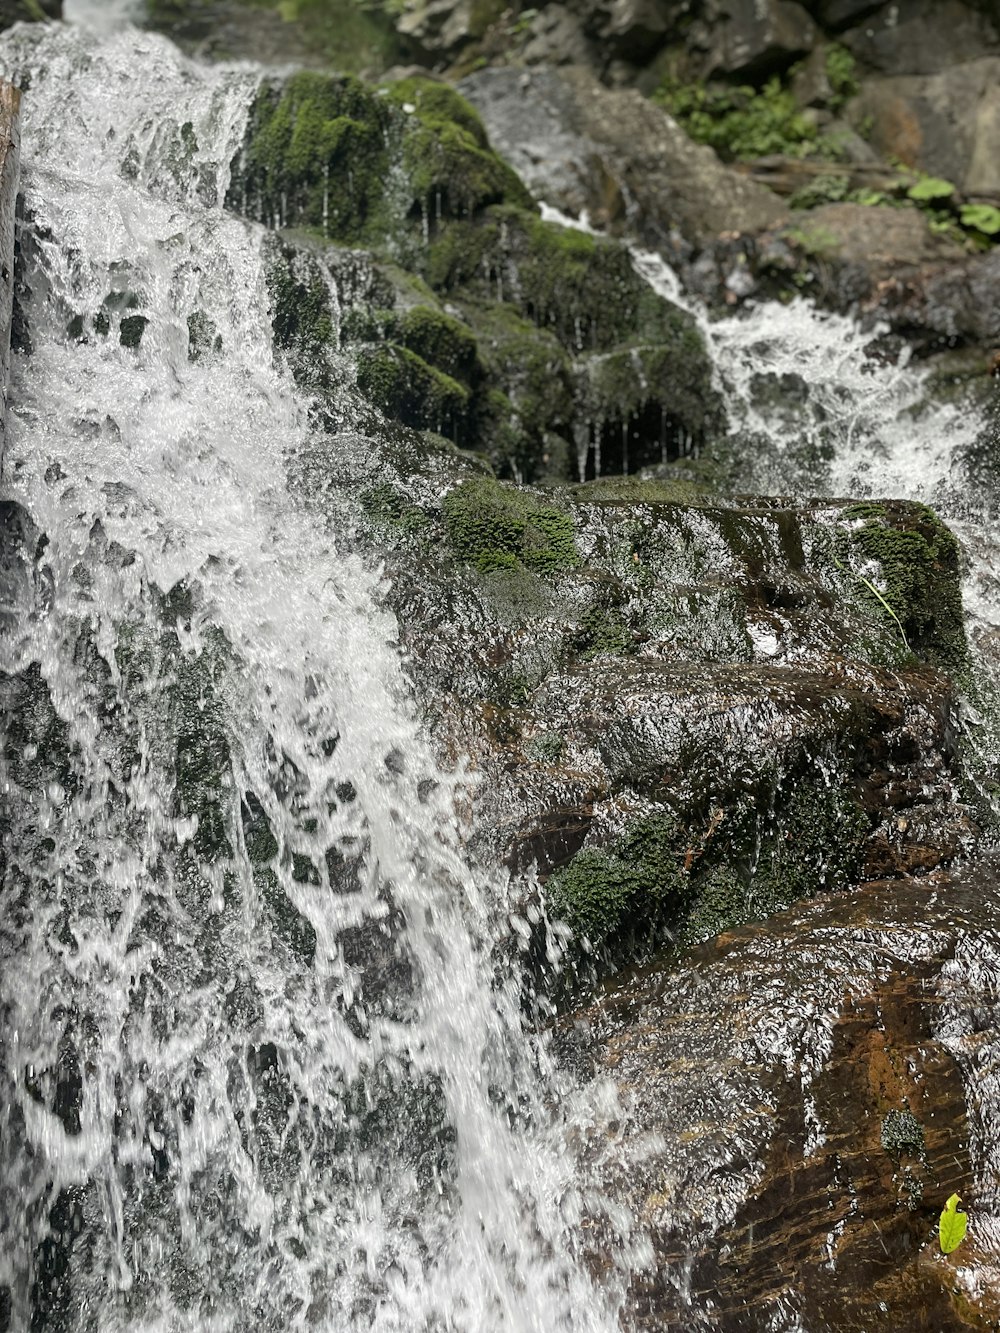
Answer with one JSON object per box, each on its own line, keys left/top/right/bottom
{"left": 0, "top": 0, "right": 989, "bottom": 1333}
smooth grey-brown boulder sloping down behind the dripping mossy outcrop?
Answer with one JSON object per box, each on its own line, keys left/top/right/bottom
{"left": 461, "top": 69, "right": 785, "bottom": 244}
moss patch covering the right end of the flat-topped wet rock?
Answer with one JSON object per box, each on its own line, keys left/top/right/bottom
{"left": 837, "top": 503, "right": 968, "bottom": 676}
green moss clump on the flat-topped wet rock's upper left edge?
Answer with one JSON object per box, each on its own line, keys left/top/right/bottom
{"left": 443, "top": 477, "right": 579, "bottom": 573}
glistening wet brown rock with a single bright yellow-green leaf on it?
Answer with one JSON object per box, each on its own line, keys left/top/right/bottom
{"left": 563, "top": 862, "right": 1000, "bottom": 1333}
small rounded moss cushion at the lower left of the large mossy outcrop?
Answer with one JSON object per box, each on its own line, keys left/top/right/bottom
{"left": 357, "top": 343, "right": 469, "bottom": 440}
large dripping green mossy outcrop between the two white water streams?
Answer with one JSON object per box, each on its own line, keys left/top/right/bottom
{"left": 227, "top": 73, "right": 723, "bottom": 481}
